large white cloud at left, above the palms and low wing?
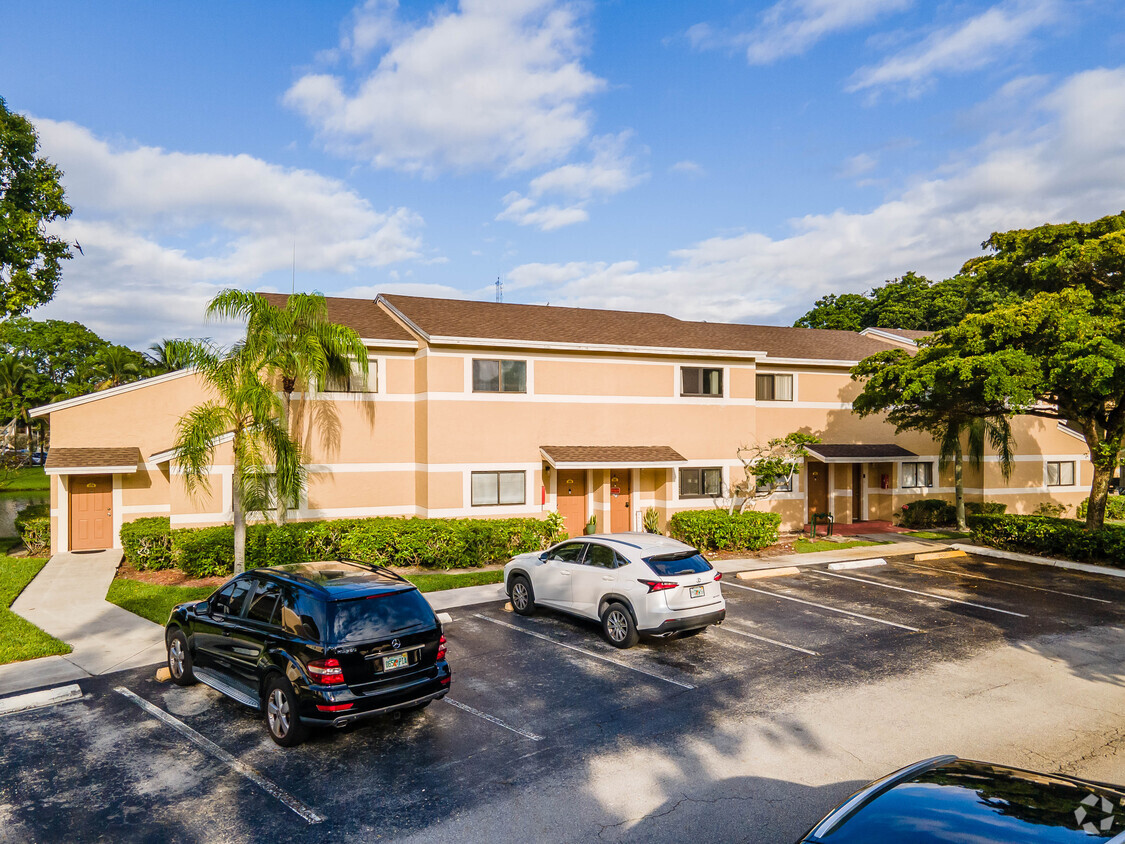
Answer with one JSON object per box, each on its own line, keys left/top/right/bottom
{"left": 35, "top": 118, "right": 422, "bottom": 343}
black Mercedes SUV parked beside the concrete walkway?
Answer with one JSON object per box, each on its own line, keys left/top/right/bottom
{"left": 164, "top": 562, "right": 451, "bottom": 747}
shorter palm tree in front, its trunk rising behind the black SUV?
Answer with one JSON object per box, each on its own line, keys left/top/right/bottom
{"left": 176, "top": 343, "right": 305, "bottom": 574}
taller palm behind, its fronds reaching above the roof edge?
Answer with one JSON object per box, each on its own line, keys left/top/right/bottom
{"left": 207, "top": 289, "right": 368, "bottom": 522}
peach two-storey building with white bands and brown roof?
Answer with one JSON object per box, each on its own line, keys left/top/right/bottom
{"left": 33, "top": 294, "right": 1092, "bottom": 551}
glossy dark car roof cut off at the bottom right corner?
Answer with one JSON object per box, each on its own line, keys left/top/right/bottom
{"left": 807, "top": 760, "right": 1125, "bottom": 844}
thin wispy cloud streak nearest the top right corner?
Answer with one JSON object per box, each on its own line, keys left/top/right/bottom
{"left": 847, "top": 0, "right": 1060, "bottom": 95}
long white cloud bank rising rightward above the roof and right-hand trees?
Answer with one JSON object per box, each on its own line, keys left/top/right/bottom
{"left": 510, "top": 69, "right": 1125, "bottom": 322}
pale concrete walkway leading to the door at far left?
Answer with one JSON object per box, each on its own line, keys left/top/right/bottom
{"left": 0, "top": 550, "right": 165, "bottom": 695}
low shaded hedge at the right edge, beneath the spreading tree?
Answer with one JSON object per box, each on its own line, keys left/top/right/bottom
{"left": 969, "top": 515, "right": 1125, "bottom": 567}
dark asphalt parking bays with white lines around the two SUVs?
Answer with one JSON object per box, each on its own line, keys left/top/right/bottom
{"left": 0, "top": 557, "right": 1125, "bottom": 842}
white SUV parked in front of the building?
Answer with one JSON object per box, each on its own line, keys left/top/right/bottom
{"left": 504, "top": 533, "right": 727, "bottom": 648}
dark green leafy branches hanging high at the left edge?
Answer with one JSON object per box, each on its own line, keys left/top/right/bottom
{"left": 0, "top": 98, "right": 71, "bottom": 316}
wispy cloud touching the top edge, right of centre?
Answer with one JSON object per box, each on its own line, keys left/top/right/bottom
{"left": 686, "top": 0, "right": 914, "bottom": 64}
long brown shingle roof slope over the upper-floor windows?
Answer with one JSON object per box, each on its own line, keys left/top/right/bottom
{"left": 380, "top": 295, "right": 887, "bottom": 360}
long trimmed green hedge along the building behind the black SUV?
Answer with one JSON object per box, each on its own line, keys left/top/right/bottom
{"left": 122, "top": 518, "right": 571, "bottom": 577}
